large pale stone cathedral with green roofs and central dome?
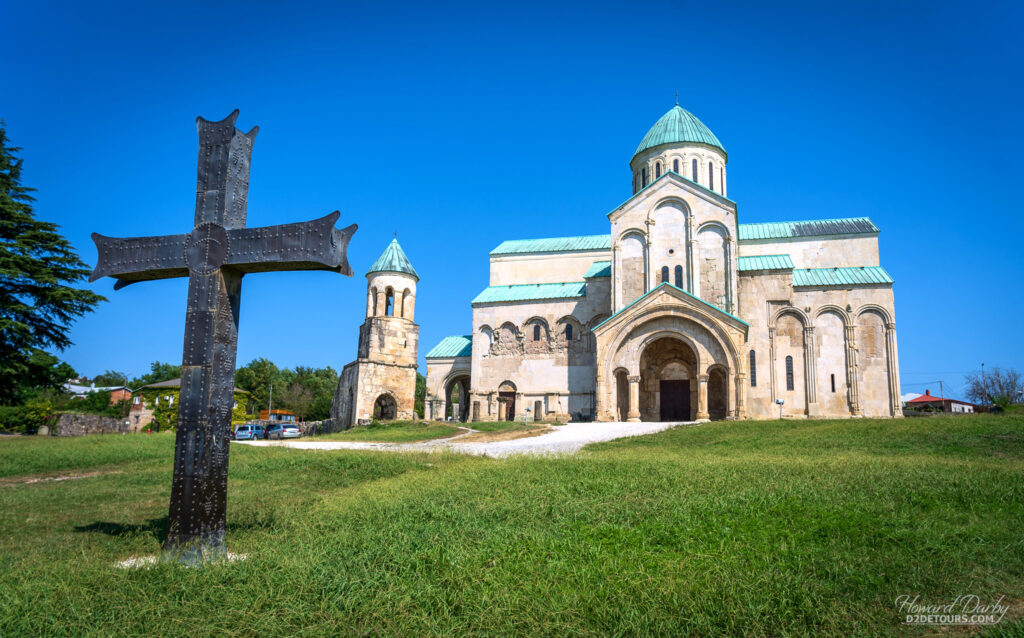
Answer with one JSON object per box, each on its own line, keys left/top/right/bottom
{"left": 426, "top": 104, "right": 901, "bottom": 422}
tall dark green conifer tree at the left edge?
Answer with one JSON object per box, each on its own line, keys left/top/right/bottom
{"left": 0, "top": 122, "right": 105, "bottom": 405}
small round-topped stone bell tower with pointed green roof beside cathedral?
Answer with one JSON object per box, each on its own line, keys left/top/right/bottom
{"left": 331, "top": 242, "right": 420, "bottom": 429}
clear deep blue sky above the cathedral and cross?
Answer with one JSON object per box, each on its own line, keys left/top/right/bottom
{"left": 0, "top": 0, "right": 1024, "bottom": 395}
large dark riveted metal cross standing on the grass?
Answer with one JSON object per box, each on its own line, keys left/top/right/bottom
{"left": 89, "top": 110, "right": 357, "bottom": 563}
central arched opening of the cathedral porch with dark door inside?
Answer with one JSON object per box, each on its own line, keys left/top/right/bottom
{"left": 640, "top": 336, "right": 697, "bottom": 421}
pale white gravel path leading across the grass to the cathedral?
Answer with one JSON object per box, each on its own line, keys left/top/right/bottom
{"left": 234, "top": 423, "right": 692, "bottom": 457}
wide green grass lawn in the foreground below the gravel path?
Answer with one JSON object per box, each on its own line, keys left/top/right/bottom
{"left": 0, "top": 415, "right": 1024, "bottom": 636}
